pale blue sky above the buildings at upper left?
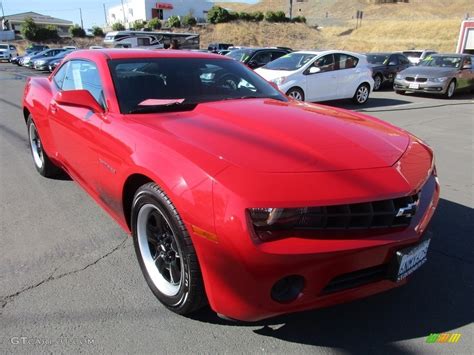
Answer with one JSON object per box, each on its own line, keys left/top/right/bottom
{"left": 0, "top": 0, "right": 257, "bottom": 28}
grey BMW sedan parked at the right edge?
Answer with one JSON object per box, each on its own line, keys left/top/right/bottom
{"left": 393, "top": 54, "right": 474, "bottom": 99}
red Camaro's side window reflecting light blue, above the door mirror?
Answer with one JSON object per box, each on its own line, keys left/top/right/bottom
{"left": 62, "top": 60, "right": 105, "bottom": 107}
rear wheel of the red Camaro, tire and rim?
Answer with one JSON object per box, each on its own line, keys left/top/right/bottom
{"left": 26, "top": 115, "right": 62, "bottom": 178}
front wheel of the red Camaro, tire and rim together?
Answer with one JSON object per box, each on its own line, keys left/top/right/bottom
{"left": 132, "top": 183, "right": 206, "bottom": 314}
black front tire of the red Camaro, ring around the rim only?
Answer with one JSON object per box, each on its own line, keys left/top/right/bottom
{"left": 131, "top": 188, "right": 191, "bottom": 312}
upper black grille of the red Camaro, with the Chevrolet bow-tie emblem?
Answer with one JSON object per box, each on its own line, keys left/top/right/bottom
{"left": 294, "top": 195, "right": 418, "bottom": 230}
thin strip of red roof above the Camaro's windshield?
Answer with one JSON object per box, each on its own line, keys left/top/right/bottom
{"left": 68, "top": 48, "right": 231, "bottom": 60}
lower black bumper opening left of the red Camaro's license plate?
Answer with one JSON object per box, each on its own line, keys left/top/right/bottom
{"left": 321, "top": 264, "right": 389, "bottom": 295}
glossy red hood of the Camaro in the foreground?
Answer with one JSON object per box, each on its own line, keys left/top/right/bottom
{"left": 137, "top": 99, "right": 410, "bottom": 173}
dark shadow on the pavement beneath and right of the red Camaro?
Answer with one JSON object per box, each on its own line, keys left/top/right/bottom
{"left": 193, "top": 199, "right": 474, "bottom": 354}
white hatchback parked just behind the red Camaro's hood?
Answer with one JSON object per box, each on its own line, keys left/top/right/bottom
{"left": 257, "top": 50, "right": 374, "bottom": 104}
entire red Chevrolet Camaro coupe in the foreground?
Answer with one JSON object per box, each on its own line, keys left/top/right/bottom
{"left": 23, "top": 50, "right": 439, "bottom": 321}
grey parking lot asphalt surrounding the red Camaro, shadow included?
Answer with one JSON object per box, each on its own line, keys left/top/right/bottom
{"left": 0, "top": 63, "right": 474, "bottom": 354}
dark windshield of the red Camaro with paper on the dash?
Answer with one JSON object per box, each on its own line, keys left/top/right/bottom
{"left": 109, "top": 58, "right": 287, "bottom": 113}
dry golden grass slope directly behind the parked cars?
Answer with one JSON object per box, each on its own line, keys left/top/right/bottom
{"left": 199, "top": 20, "right": 460, "bottom": 52}
